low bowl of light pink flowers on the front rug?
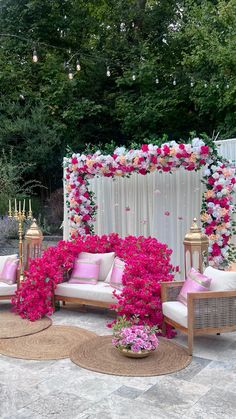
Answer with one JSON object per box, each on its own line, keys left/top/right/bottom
{"left": 112, "top": 317, "right": 159, "bottom": 358}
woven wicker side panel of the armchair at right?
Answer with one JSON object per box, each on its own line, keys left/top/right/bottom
{"left": 187, "top": 290, "right": 236, "bottom": 329}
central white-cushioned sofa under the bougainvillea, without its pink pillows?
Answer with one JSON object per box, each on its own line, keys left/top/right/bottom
{"left": 54, "top": 252, "right": 120, "bottom": 308}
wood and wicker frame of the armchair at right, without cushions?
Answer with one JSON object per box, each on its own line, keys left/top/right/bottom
{"left": 161, "top": 281, "right": 236, "bottom": 355}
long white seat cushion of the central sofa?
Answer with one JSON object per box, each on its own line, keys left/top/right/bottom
{"left": 55, "top": 281, "right": 119, "bottom": 304}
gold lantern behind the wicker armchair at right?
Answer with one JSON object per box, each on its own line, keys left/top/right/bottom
{"left": 184, "top": 218, "right": 209, "bottom": 278}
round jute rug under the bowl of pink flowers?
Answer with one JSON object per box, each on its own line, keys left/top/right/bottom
{"left": 70, "top": 336, "right": 192, "bottom": 377}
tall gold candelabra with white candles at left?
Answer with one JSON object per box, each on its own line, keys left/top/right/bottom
{"left": 8, "top": 199, "right": 33, "bottom": 276}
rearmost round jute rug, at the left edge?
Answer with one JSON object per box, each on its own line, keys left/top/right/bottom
{"left": 0, "top": 311, "right": 52, "bottom": 339}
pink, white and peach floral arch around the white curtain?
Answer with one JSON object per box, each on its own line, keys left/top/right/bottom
{"left": 64, "top": 138, "right": 236, "bottom": 267}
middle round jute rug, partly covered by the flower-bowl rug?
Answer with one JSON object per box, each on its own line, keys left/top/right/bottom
{"left": 0, "top": 326, "right": 97, "bottom": 360}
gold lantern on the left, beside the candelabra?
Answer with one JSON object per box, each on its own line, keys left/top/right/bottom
{"left": 24, "top": 219, "right": 43, "bottom": 269}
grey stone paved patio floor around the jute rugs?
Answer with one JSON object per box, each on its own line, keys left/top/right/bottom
{"left": 0, "top": 303, "right": 236, "bottom": 419}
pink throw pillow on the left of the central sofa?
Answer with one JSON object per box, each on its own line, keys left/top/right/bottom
{"left": 68, "top": 259, "right": 100, "bottom": 285}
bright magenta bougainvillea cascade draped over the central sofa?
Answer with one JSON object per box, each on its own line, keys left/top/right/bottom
{"left": 12, "top": 234, "right": 177, "bottom": 334}
